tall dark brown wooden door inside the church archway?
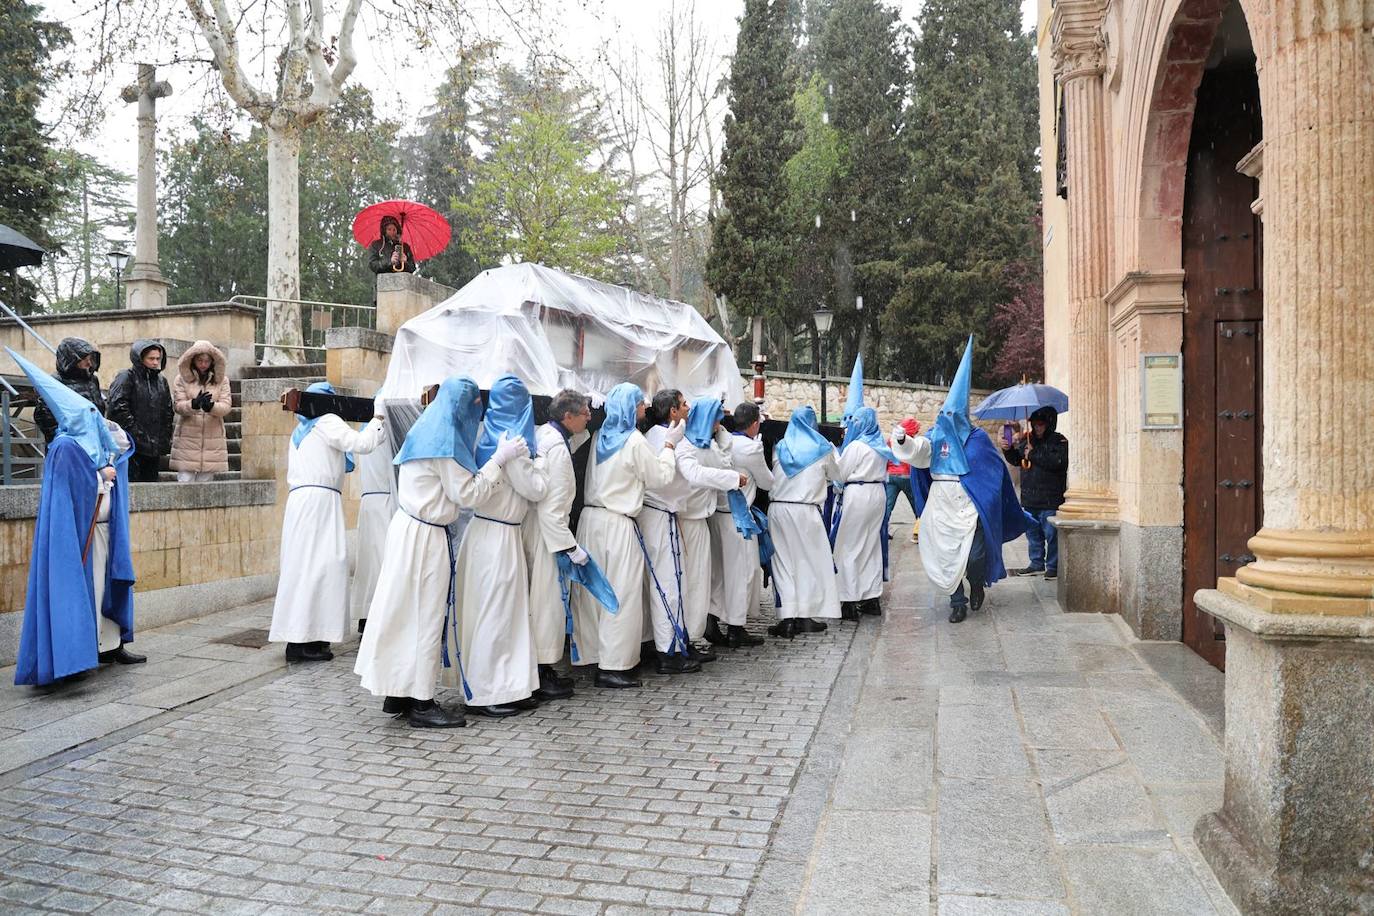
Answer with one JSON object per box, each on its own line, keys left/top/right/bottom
{"left": 1182, "top": 0, "right": 1264, "bottom": 667}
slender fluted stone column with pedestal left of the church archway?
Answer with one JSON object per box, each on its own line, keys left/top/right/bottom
{"left": 1051, "top": 0, "right": 1120, "bottom": 612}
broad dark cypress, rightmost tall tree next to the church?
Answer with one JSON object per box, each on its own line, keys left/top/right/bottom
{"left": 883, "top": 0, "right": 1039, "bottom": 382}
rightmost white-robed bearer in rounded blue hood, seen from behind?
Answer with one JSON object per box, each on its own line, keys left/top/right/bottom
{"left": 834, "top": 407, "right": 894, "bottom": 621}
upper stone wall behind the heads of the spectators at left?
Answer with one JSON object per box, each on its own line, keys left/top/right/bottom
{"left": 0, "top": 302, "right": 262, "bottom": 376}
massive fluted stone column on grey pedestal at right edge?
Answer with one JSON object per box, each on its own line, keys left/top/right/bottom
{"left": 1197, "top": 8, "right": 1374, "bottom": 913}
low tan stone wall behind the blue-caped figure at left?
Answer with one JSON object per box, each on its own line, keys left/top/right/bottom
{"left": 0, "top": 481, "right": 282, "bottom": 666}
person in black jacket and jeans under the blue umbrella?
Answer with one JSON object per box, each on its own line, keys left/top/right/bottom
{"left": 1002, "top": 407, "right": 1069, "bottom": 580}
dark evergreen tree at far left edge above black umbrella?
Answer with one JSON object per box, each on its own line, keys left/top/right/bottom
{"left": 0, "top": 0, "right": 71, "bottom": 312}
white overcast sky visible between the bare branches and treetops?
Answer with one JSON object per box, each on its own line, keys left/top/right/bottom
{"left": 40, "top": 0, "right": 1036, "bottom": 233}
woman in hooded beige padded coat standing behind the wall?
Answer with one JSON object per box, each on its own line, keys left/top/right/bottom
{"left": 172, "top": 341, "right": 234, "bottom": 483}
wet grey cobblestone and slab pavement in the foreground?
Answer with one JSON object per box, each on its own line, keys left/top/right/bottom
{"left": 0, "top": 516, "right": 1228, "bottom": 916}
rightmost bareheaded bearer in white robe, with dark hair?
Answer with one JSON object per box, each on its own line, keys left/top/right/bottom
{"left": 706, "top": 401, "right": 774, "bottom": 648}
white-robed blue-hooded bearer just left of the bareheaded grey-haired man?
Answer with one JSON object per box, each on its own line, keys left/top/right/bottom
{"left": 453, "top": 375, "right": 548, "bottom": 718}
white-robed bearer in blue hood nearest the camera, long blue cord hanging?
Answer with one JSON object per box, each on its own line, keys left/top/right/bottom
{"left": 353, "top": 376, "right": 526, "bottom": 728}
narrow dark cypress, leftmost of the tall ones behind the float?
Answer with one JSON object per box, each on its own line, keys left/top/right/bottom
{"left": 706, "top": 0, "right": 796, "bottom": 346}
